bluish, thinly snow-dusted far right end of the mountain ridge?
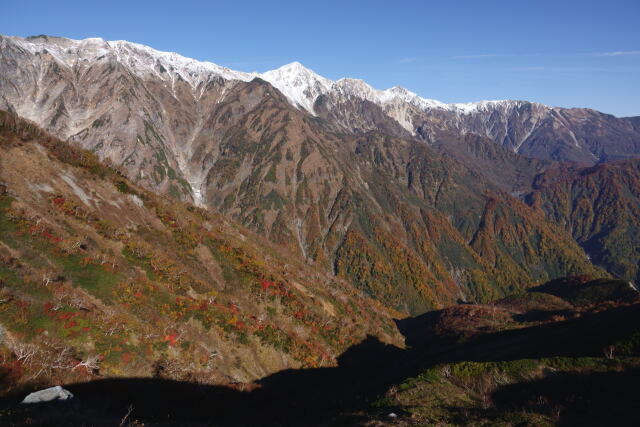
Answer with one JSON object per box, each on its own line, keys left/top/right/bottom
{"left": 414, "top": 101, "right": 640, "bottom": 165}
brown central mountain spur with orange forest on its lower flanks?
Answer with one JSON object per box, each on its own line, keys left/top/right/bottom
{"left": 199, "top": 88, "right": 604, "bottom": 313}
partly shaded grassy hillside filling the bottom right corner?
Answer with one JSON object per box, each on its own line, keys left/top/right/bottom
{"left": 368, "top": 277, "right": 640, "bottom": 426}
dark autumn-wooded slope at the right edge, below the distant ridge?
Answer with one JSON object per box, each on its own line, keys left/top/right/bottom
{"left": 527, "top": 160, "right": 640, "bottom": 283}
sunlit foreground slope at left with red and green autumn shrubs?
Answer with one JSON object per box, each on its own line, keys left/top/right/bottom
{"left": 0, "top": 112, "right": 401, "bottom": 393}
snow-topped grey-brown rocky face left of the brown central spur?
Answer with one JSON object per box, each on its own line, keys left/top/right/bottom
{"left": 0, "top": 33, "right": 262, "bottom": 201}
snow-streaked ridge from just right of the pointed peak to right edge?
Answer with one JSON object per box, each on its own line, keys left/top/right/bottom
{"left": 314, "top": 79, "right": 640, "bottom": 165}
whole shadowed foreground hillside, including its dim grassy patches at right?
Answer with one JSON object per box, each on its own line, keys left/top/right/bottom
{"left": 1, "top": 283, "right": 640, "bottom": 425}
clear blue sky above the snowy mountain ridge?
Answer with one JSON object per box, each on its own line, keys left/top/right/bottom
{"left": 0, "top": 0, "right": 640, "bottom": 116}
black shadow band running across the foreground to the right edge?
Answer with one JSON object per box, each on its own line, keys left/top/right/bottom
{"left": 4, "top": 305, "right": 640, "bottom": 425}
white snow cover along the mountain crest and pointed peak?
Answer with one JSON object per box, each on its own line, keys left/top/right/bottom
{"left": 0, "top": 32, "right": 544, "bottom": 120}
